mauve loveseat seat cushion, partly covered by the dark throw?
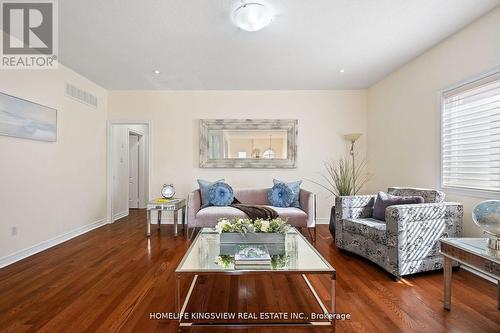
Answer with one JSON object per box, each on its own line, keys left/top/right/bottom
{"left": 196, "top": 206, "right": 307, "bottom": 227}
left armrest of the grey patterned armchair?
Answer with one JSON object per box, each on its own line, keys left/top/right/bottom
{"left": 335, "top": 195, "right": 377, "bottom": 249}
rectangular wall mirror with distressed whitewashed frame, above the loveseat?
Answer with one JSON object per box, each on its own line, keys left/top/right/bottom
{"left": 200, "top": 119, "right": 297, "bottom": 168}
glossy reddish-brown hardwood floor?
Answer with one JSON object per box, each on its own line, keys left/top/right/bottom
{"left": 0, "top": 211, "right": 500, "bottom": 332}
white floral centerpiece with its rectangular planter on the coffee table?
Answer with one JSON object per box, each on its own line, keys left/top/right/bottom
{"left": 215, "top": 218, "right": 290, "bottom": 244}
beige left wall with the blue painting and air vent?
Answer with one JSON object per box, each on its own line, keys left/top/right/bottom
{"left": 0, "top": 65, "right": 107, "bottom": 258}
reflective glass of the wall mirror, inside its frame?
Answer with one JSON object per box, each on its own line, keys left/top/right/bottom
{"left": 208, "top": 129, "right": 288, "bottom": 159}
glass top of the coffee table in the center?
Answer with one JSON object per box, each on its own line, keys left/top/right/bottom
{"left": 176, "top": 228, "right": 335, "bottom": 274}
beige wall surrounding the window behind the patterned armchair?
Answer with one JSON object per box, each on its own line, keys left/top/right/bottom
{"left": 368, "top": 7, "right": 500, "bottom": 235}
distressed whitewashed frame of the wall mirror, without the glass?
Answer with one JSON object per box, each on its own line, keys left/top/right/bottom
{"left": 200, "top": 119, "right": 298, "bottom": 169}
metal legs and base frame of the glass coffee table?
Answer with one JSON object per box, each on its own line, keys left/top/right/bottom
{"left": 176, "top": 271, "right": 336, "bottom": 332}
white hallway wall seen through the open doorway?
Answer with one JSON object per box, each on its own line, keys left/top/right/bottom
{"left": 111, "top": 124, "right": 149, "bottom": 220}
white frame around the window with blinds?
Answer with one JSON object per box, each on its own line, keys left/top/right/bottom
{"left": 438, "top": 66, "right": 500, "bottom": 199}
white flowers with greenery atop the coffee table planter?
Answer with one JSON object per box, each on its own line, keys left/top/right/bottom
{"left": 215, "top": 218, "right": 290, "bottom": 235}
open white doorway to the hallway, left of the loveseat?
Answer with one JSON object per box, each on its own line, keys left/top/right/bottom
{"left": 108, "top": 122, "right": 150, "bottom": 222}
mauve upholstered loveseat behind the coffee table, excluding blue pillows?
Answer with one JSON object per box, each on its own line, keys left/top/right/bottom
{"left": 187, "top": 188, "right": 316, "bottom": 239}
